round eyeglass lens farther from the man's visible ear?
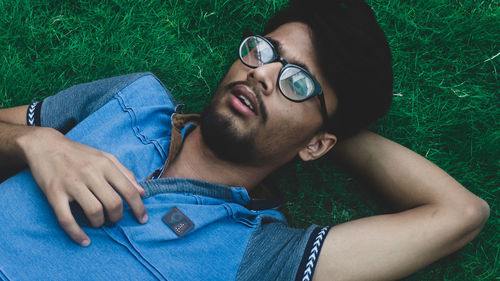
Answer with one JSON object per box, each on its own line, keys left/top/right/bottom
{"left": 240, "top": 36, "right": 274, "bottom": 67}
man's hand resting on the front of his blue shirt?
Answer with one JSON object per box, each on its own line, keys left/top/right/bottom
{"left": 17, "top": 128, "right": 148, "bottom": 246}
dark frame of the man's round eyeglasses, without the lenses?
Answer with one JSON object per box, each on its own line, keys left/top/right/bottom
{"left": 238, "top": 35, "right": 328, "bottom": 130}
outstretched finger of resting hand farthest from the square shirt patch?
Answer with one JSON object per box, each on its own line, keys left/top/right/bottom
{"left": 49, "top": 197, "right": 90, "bottom": 247}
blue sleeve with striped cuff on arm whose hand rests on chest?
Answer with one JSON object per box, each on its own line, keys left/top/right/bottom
{"left": 26, "top": 72, "right": 158, "bottom": 133}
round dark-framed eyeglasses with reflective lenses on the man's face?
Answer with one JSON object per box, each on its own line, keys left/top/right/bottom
{"left": 238, "top": 35, "right": 328, "bottom": 129}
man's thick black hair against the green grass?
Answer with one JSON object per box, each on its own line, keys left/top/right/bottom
{"left": 264, "top": 0, "right": 393, "bottom": 140}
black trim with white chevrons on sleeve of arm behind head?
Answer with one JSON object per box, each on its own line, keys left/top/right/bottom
{"left": 295, "top": 226, "right": 330, "bottom": 281}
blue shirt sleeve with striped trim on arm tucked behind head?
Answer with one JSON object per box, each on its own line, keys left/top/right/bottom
{"left": 236, "top": 222, "right": 330, "bottom": 281}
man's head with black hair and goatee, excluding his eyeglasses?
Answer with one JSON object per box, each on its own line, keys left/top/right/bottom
{"left": 201, "top": 1, "right": 392, "bottom": 166}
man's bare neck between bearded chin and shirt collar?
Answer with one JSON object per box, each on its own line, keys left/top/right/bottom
{"left": 161, "top": 127, "right": 276, "bottom": 191}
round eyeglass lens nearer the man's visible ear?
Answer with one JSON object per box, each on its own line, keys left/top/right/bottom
{"left": 279, "top": 66, "right": 314, "bottom": 101}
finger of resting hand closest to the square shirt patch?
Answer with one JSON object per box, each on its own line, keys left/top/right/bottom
{"left": 107, "top": 173, "right": 148, "bottom": 223}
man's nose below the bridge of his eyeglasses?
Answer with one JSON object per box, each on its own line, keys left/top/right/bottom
{"left": 247, "top": 62, "right": 282, "bottom": 95}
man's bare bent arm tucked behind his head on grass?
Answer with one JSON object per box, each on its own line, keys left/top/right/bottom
{"left": 314, "top": 131, "right": 489, "bottom": 280}
